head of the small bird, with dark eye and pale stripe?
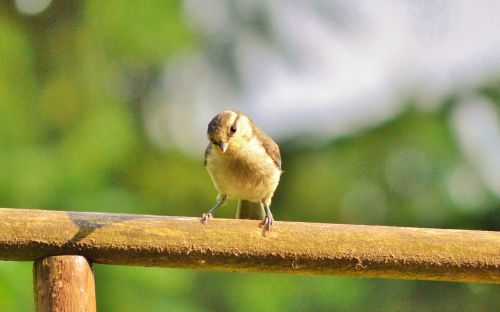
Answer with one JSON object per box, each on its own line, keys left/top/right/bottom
{"left": 207, "top": 110, "right": 252, "bottom": 153}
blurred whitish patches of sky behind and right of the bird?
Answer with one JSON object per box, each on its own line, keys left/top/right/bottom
{"left": 145, "top": 0, "right": 500, "bottom": 195}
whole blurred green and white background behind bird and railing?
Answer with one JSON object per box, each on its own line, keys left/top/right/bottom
{"left": 0, "top": 0, "right": 500, "bottom": 311}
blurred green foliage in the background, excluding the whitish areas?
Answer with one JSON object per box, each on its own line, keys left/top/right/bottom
{"left": 0, "top": 0, "right": 500, "bottom": 311}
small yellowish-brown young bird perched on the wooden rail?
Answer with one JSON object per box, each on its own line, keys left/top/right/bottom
{"left": 202, "top": 110, "right": 282, "bottom": 231}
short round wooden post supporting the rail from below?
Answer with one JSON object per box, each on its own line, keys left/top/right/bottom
{"left": 33, "top": 256, "right": 96, "bottom": 312}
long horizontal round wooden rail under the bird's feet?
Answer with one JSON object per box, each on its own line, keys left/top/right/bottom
{"left": 0, "top": 208, "right": 500, "bottom": 283}
